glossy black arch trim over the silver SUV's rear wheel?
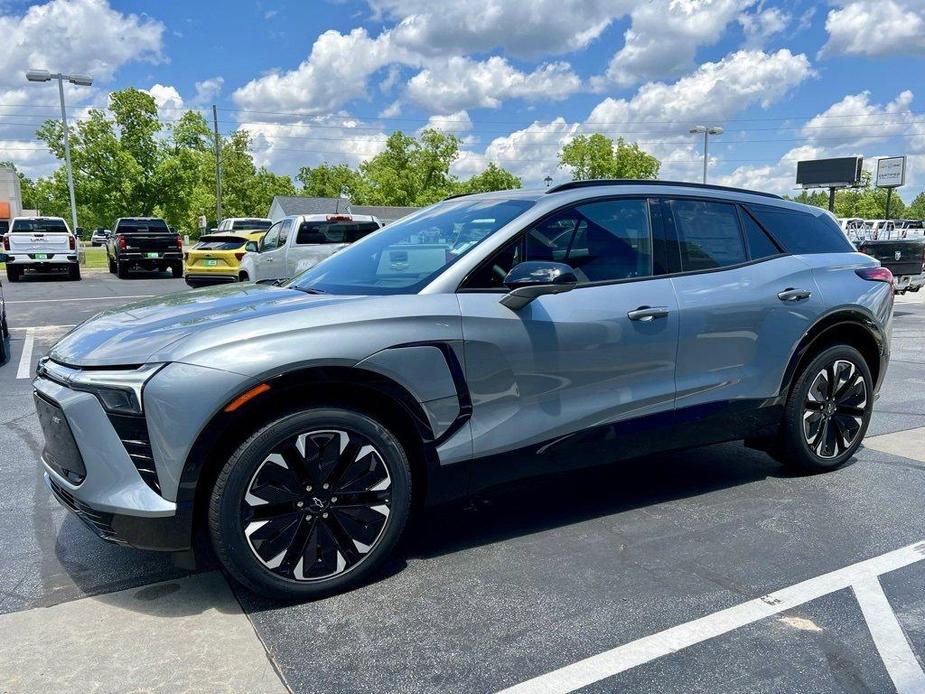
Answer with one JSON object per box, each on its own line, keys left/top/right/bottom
{"left": 780, "top": 307, "right": 889, "bottom": 398}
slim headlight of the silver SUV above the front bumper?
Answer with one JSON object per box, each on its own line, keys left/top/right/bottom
{"left": 38, "top": 357, "right": 164, "bottom": 415}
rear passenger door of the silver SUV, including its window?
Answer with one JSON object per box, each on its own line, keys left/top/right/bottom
{"left": 664, "top": 199, "right": 825, "bottom": 424}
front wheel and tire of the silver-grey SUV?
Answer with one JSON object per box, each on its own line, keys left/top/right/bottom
{"left": 209, "top": 409, "right": 411, "bottom": 599}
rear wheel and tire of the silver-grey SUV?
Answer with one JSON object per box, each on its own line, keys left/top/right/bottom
{"left": 778, "top": 345, "right": 874, "bottom": 473}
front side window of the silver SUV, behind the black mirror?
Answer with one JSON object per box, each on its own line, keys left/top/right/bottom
{"left": 465, "top": 199, "right": 652, "bottom": 289}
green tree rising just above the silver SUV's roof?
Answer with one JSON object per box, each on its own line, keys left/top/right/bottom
{"left": 559, "top": 133, "right": 661, "bottom": 181}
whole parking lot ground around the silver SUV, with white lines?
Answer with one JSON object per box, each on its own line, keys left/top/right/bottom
{"left": 0, "top": 273, "right": 925, "bottom": 692}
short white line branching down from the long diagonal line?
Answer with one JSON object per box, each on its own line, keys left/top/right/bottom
{"left": 852, "top": 576, "right": 925, "bottom": 694}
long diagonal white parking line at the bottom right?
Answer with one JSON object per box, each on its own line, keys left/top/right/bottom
{"left": 502, "top": 542, "right": 925, "bottom": 694}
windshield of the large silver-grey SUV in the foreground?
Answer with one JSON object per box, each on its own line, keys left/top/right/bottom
{"left": 288, "top": 198, "right": 534, "bottom": 294}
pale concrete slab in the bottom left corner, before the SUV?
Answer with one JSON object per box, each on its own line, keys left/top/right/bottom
{"left": 0, "top": 572, "right": 288, "bottom": 694}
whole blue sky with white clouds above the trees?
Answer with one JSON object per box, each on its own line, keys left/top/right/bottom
{"left": 0, "top": 0, "right": 925, "bottom": 200}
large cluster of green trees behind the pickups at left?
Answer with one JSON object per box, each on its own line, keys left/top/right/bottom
{"left": 29, "top": 89, "right": 295, "bottom": 232}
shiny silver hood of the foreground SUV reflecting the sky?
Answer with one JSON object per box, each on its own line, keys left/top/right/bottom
{"left": 49, "top": 284, "right": 362, "bottom": 366}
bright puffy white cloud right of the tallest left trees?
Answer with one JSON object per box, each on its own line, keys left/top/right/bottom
{"left": 232, "top": 29, "right": 416, "bottom": 113}
